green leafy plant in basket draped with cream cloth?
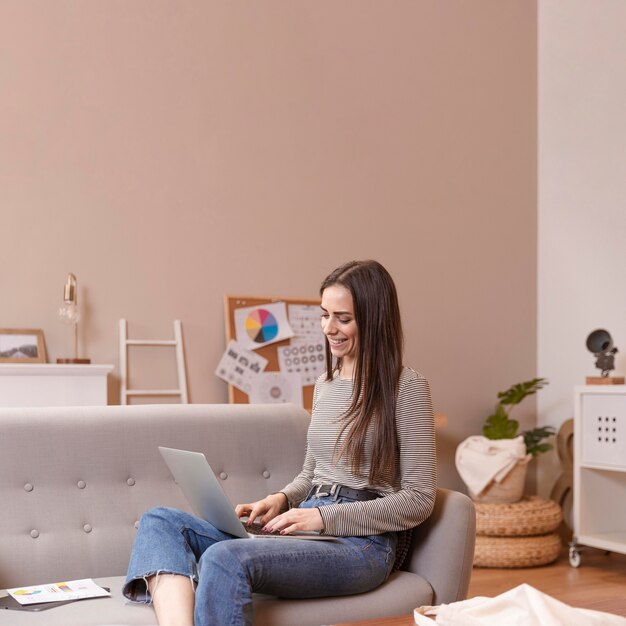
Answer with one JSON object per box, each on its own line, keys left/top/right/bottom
{"left": 456, "top": 378, "right": 555, "bottom": 503}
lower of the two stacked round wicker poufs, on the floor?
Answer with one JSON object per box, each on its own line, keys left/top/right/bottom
{"left": 474, "top": 533, "right": 561, "bottom": 568}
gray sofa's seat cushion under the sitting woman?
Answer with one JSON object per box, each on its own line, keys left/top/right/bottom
{"left": 0, "top": 572, "right": 433, "bottom": 626}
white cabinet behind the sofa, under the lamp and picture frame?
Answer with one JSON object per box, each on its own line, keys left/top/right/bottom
{"left": 0, "top": 363, "right": 113, "bottom": 407}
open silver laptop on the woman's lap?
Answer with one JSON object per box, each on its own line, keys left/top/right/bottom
{"left": 159, "top": 446, "right": 334, "bottom": 541}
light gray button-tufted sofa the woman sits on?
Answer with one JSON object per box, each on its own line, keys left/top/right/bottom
{"left": 0, "top": 405, "right": 475, "bottom": 626}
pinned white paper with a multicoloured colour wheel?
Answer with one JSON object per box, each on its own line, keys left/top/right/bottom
{"left": 235, "top": 302, "right": 294, "bottom": 350}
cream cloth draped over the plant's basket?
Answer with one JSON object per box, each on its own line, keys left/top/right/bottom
{"left": 455, "top": 435, "right": 528, "bottom": 495}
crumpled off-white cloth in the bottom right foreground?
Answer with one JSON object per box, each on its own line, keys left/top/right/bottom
{"left": 414, "top": 584, "right": 626, "bottom": 626}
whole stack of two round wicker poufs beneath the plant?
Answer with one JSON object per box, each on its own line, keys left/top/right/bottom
{"left": 474, "top": 496, "right": 562, "bottom": 568}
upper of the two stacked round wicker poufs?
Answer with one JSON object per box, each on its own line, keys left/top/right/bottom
{"left": 475, "top": 496, "right": 563, "bottom": 537}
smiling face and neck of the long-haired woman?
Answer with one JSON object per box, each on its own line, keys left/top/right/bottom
{"left": 322, "top": 285, "right": 359, "bottom": 376}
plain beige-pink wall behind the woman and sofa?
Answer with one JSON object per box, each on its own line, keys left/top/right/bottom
{"left": 0, "top": 0, "right": 536, "bottom": 486}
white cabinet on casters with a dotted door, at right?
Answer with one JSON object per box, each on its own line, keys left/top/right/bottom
{"left": 570, "top": 385, "right": 626, "bottom": 567}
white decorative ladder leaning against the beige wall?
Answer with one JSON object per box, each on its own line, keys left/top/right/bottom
{"left": 120, "top": 319, "right": 189, "bottom": 404}
